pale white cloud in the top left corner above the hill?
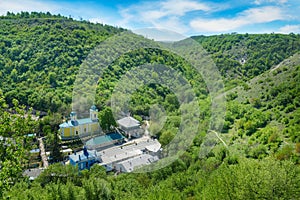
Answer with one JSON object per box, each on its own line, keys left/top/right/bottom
{"left": 0, "top": 0, "right": 60, "bottom": 15}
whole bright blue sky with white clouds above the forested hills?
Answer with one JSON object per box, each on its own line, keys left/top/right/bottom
{"left": 0, "top": 0, "right": 300, "bottom": 36}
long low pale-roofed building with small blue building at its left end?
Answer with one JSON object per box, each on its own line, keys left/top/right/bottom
{"left": 69, "top": 136, "right": 161, "bottom": 172}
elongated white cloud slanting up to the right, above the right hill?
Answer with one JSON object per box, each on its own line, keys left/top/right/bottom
{"left": 190, "top": 6, "right": 284, "bottom": 32}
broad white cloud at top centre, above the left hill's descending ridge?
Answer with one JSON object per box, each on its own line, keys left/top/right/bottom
{"left": 119, "top": 0, "right": 211, "bottom": 33}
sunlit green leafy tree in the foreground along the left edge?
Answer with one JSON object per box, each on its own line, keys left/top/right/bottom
{"left": 0, "top": 95, "right": 36, "bottom": 197}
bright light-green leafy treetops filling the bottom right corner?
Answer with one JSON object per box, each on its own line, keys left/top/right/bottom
{"left": 202, "top": 158, "right": 300, "bottom": 199}
